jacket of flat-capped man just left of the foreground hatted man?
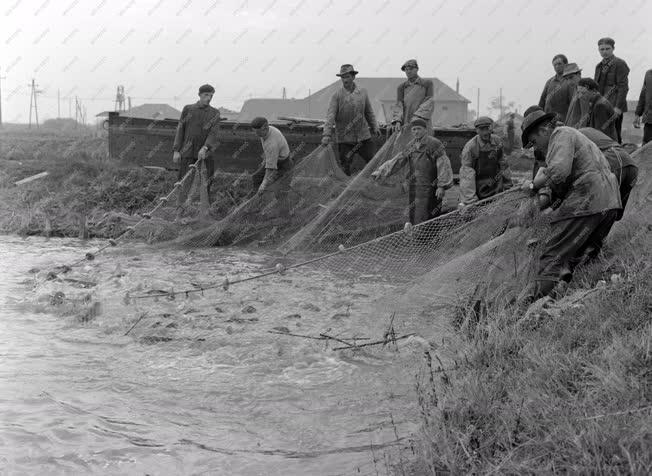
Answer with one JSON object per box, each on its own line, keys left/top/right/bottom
{"left": 460, "top": 134, "right": 512, "bottom": 204}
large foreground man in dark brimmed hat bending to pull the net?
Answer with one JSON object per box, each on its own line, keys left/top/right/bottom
{"left": 521, "top": 111, "right": 622, "bottom": 304}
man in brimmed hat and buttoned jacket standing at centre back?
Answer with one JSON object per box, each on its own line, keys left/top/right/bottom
{"left": 321, "top": 64, "right": 380, "bottom": 175}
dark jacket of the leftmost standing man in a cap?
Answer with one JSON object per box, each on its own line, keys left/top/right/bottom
{"left": 172, "top": 102, "right": 220, "bottom": 159}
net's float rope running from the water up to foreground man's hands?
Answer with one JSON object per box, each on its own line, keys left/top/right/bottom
{"left": 126, "top": 187, "right": 520, "bottom": 300}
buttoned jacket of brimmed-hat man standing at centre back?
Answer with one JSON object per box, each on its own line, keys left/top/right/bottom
{"left": 324, "top": 83, "right": 378, "bottom": 143}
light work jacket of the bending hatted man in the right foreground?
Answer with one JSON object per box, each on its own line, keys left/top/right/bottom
{"left": 543, "top": 126, "right": 622, "bottom": 221}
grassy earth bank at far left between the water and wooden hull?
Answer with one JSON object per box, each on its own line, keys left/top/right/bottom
{"left": 0, "top": 131, "right": 248, "bottom": 241}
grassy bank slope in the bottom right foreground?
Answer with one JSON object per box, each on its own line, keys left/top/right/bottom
{"left": 403, "top": 215, "right": 652, "bottom": 474}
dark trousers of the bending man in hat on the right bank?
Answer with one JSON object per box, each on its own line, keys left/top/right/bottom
{"left": 533, "top": 210, "right": 618, "bottom": 299}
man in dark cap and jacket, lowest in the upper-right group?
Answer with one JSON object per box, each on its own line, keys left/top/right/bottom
{"left": 566, "top": 78, "right": 618, "bottom": 141}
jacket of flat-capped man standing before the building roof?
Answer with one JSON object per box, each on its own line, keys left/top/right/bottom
{"left": 392, "top": 76, "right": 434, "bottom": 125}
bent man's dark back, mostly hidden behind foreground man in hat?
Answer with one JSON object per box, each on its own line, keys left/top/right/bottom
{"left": 579, "top": 127, "right": 638, "bottom": 221}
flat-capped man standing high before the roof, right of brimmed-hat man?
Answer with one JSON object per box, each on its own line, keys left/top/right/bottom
{"left": 392, "top": 59, "right": 434, "bottom": 134}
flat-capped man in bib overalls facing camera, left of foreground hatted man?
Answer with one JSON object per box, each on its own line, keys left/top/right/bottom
{"left": 460, "top": 116, "right": 512, "bottom": 207}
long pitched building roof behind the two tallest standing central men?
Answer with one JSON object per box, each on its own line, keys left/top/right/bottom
{"left": 238, "top": 77, "right": 471, "bottom": 122}
